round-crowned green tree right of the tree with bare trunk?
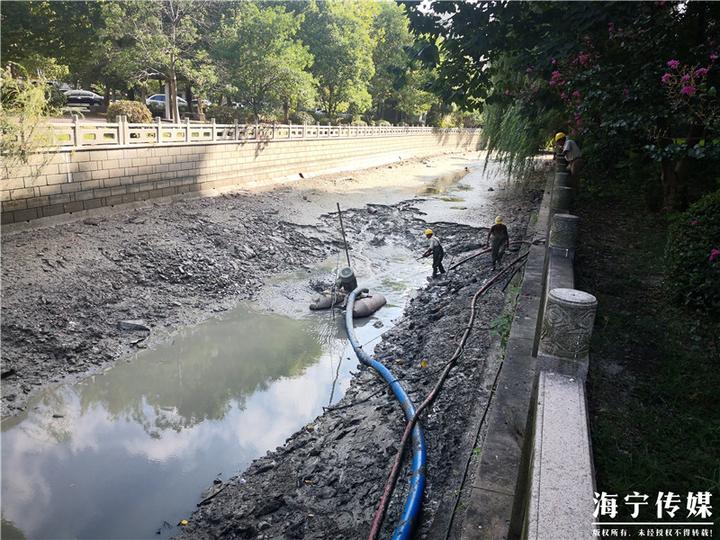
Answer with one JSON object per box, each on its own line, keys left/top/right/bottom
{"left": 213, "top": 2, "right": 314, "bottom": 122}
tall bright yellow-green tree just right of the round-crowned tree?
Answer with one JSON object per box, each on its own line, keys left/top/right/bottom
{"left": 302, "top": 0, "right": 379, "bottom": 118}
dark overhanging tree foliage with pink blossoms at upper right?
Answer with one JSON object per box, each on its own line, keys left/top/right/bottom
{"left": 408, "top": 2, "right": 720, "bottom": 209}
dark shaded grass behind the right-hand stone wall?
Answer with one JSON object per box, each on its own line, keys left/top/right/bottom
{"left": 576, "top": 186, "right": 720, "bottom": 529}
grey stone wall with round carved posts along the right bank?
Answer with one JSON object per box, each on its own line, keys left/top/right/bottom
{"left": 461, "top": 161, "right": 597, "bottom": 540}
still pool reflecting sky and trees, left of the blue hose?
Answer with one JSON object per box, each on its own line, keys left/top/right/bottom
{"left": 2, "top": 309, "right": 349, "bottom": 538}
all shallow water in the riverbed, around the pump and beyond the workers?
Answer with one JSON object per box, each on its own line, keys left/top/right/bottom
{"left": 2, "top": 154, "right": 516, "bottom": 539}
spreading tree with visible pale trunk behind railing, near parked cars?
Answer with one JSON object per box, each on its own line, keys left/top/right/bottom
{"left": 102, "top": 0, "right": 214, "bottom": 121}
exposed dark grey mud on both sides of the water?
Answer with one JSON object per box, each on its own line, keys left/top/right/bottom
{"left": 2, "top": 153, "right": 540, "bottom": 538}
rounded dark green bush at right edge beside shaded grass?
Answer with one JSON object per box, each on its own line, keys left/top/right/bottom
{"left": 665, "top": 190, "right": 720, "bottom": 312}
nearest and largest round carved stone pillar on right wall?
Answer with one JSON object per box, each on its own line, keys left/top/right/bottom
{"left": 538, "top": 288, "right": 597, "bottom": 378}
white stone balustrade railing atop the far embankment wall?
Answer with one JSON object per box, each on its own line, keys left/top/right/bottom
{"left": 32, "top": 116, "right": 475, "bottom": 150}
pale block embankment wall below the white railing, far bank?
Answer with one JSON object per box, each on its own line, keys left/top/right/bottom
{"left": 0, "top": 130, "right": 480, "bottom": 228}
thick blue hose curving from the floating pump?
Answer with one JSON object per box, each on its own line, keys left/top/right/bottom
{"left": 345, "top": 287, "right": 426, "bottom": 540}
